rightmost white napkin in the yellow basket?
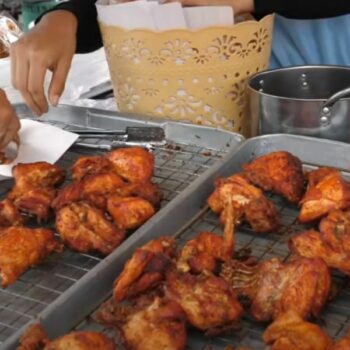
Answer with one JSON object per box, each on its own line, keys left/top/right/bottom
{"left": 183, "top": 6, "right": 234, "bottom": 29}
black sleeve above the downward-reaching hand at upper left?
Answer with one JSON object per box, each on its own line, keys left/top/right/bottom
{"left": 43, "top": 0, "right": 102, "bottom": 53}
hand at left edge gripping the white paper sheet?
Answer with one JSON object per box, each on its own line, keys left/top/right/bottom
{"left": 0, "top": 89, "right": 20, "bottom": 150}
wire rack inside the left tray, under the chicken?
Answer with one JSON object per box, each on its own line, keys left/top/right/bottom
{"left": 0, "top": 122, "right": 224, "bottom": 347}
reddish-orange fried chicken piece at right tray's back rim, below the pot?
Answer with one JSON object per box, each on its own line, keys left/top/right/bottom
{"left": 243, "top": 151, "right": 304, "bottom": 203}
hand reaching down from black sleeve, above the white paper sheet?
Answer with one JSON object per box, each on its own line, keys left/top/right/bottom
{"left": 10, "top": 10, "right": 78, "bottom": 116}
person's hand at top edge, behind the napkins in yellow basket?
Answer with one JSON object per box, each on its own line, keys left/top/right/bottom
{"left": 165, "top": 0, "right": 254, "bottom": 16}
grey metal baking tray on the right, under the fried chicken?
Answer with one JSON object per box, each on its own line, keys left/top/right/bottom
{"left": 3, "top": 135, "right": 350, "bottom": 350}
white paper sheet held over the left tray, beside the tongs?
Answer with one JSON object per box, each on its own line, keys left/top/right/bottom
{"left": 0, "top": 119, "right": 78, "bottom": 179}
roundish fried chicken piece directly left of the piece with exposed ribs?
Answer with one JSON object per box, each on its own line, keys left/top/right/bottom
{"left": 166, "top": 271, "right": 243, "bottom": 335}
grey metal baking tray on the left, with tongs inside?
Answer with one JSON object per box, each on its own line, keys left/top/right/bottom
{"left": 0, "top": 105, "right": 243, "bottom": 349}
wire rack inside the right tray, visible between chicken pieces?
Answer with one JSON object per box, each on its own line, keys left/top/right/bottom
{"left": 69, "top": 165, "right": 350, "bottom": 350}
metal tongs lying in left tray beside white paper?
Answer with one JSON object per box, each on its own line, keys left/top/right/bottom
{"left": 69, "top": 126, "right": 166, "bottom": 151}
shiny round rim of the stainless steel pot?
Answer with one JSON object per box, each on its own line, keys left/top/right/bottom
{"left": 247, "top": 64, "right": 350, "bottom": 103}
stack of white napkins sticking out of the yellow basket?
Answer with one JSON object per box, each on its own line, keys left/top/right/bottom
{"left": 96, "top": 0, "right": 234, "bottom": 31}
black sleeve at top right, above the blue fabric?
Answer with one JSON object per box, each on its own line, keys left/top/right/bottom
{"left": 254, "top": 0, "right": 350, "bottom": 19}
